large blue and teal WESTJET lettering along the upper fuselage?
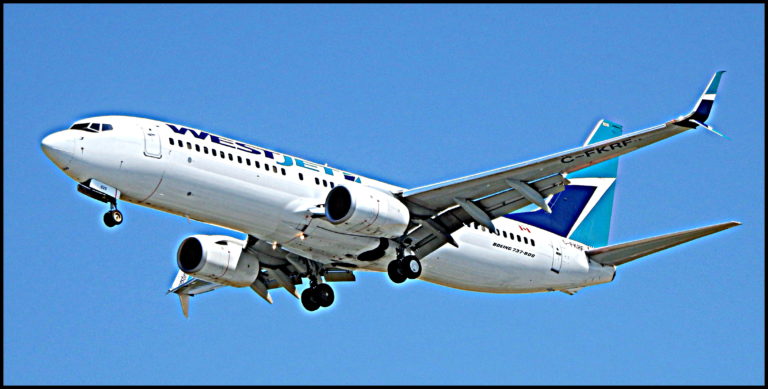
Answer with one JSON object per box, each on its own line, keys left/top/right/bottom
{"left": 166, "top": 123, "right": 360, "bottom": 183}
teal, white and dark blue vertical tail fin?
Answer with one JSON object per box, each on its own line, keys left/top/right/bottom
{"left": 506, "top": 120, "right": 622, "bottom": 247}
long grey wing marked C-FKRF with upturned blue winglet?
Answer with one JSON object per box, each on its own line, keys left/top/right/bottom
{"left": 400, "top": 71, "right": 723, "bottom": 258}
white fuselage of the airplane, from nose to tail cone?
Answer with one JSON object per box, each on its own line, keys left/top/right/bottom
{"left": 44, "top": 116, "right": 615, "bottom": 293}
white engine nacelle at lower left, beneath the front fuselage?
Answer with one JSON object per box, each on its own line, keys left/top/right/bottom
{"left": 176, "top": 235, "right": 259, "bottom": 287}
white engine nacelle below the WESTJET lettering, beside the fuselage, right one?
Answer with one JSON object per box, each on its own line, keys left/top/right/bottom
{"left": 325, "top": 185, "right": 410, "bottom": 238}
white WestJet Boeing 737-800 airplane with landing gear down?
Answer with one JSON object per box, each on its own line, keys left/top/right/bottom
{"left": 42, "top": 71, "right": 741, "bottom": 317}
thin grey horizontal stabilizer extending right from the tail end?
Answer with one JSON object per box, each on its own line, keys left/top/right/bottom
{"left": 586, "top": 222, "right": 741, "bottom": 266}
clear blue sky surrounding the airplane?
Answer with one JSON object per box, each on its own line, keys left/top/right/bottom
{"left": 3, "top": 5, "right": 765, "bottom": 384}
